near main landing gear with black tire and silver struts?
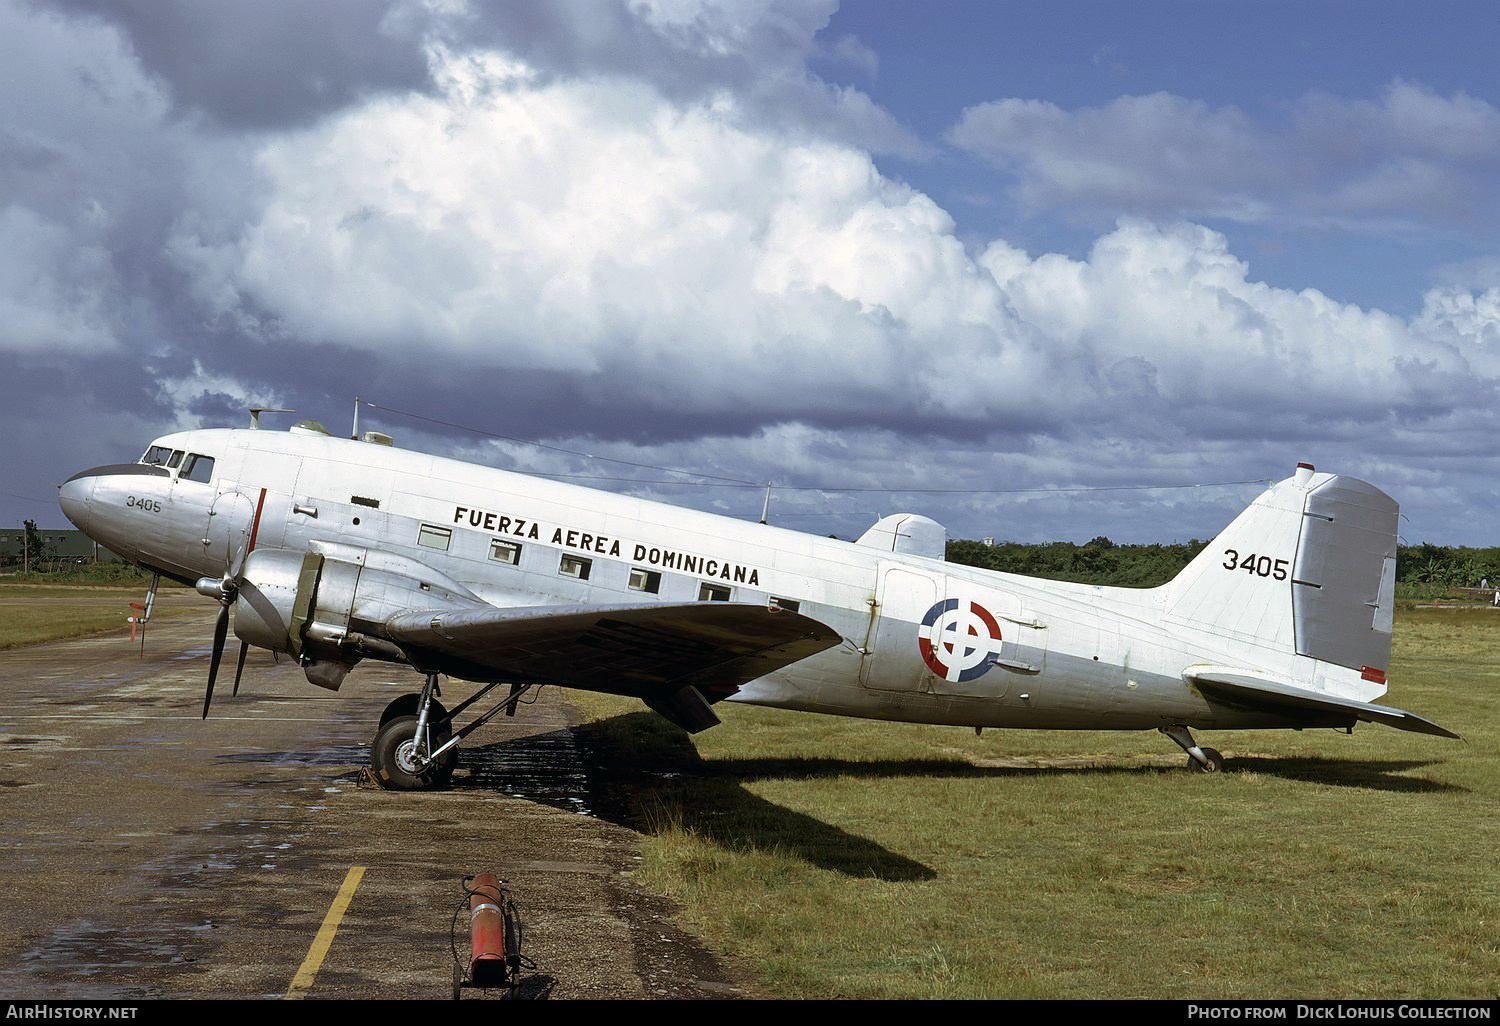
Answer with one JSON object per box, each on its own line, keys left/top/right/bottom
{"left": 371, "top": 674, "right": 533, "bottom": 791}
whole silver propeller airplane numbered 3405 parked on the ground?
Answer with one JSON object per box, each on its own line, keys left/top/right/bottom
{"left": 59, "top": 416, "right": 1460, "bottom": 791}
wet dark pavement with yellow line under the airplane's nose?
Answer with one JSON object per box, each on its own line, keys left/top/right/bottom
{"left": 0, "top": 594, "right": 750, "bottom": 1001}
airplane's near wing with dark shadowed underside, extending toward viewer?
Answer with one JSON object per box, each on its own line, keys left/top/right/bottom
{"left": 386, "top": 602, "right": 840, "bottom": 732}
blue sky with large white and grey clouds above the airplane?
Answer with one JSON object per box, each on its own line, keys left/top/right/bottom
{"left": 0, "top": 0, "right": 1500, "bottom": 545}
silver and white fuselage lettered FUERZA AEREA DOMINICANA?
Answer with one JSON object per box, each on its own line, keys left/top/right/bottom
{"left": 62, "top": 429, "right": 1385, "bottom": 729}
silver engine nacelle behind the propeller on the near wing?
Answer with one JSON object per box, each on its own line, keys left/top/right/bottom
{"left": 234, "top": 543, "right": 485, "bottom": 692}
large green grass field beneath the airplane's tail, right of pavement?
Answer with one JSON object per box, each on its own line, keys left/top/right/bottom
{"left": 567, "top": 609, "right": 1500, "bottom": 998}
